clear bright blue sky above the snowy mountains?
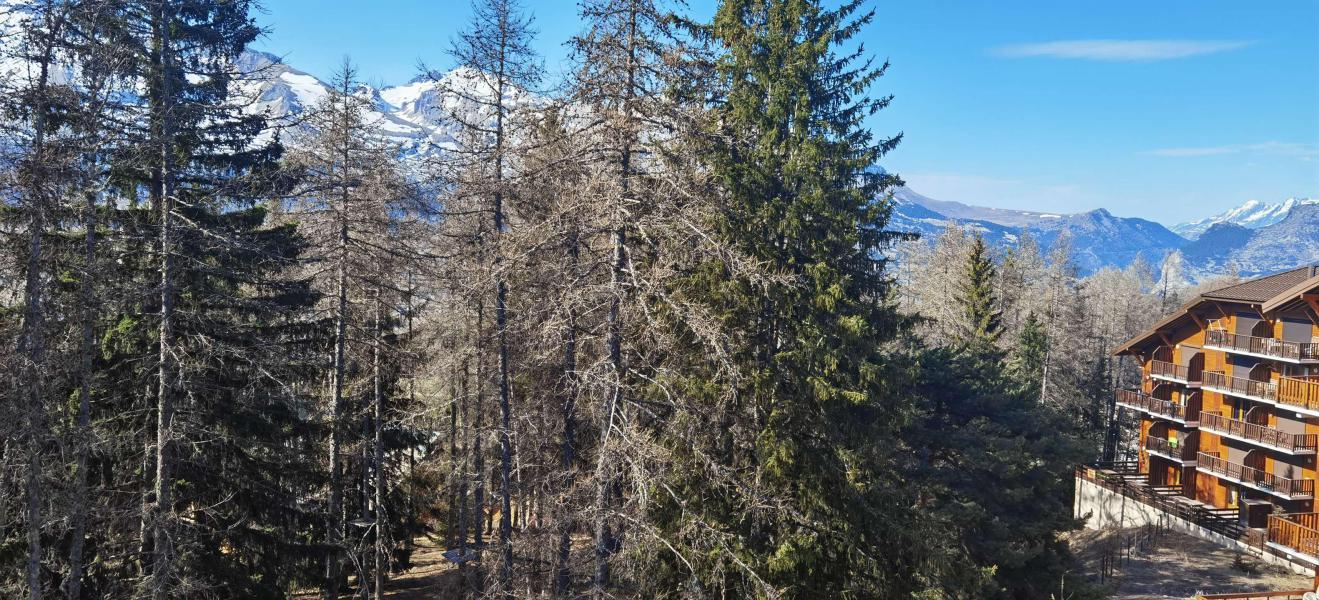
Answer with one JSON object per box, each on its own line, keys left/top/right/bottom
{"left": 257, "top": 0, "right": 1319, "bottom": 224}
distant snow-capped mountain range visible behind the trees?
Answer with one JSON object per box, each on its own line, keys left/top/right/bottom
{"left": 232, "top": 51, "right": 1319, "bottom": 278}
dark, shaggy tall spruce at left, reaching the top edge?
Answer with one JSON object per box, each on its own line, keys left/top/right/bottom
{"left": 92, "top": 0, "right": 327, "bottom": 599}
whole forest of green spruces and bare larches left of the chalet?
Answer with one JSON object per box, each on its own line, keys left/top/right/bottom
{"left": 0, "top": 0, "right": 1218, "bottom": 599}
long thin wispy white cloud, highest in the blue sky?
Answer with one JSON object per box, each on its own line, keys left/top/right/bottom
{"left": 993, "top": 40, "right": 1252, "bottom": 61}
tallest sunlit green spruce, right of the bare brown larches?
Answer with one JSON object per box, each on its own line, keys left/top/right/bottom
{"left": 646, "top": 0, "right": 919, "bottom": 597}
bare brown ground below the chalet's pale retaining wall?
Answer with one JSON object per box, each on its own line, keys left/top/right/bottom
{"left": 1068, "top": 529, "right": 1314, "bottom": 600}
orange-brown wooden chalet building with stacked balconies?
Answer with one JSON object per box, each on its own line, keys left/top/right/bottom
{"left": 1116, "top": 265, "right": 1319, "bottom": 564}
